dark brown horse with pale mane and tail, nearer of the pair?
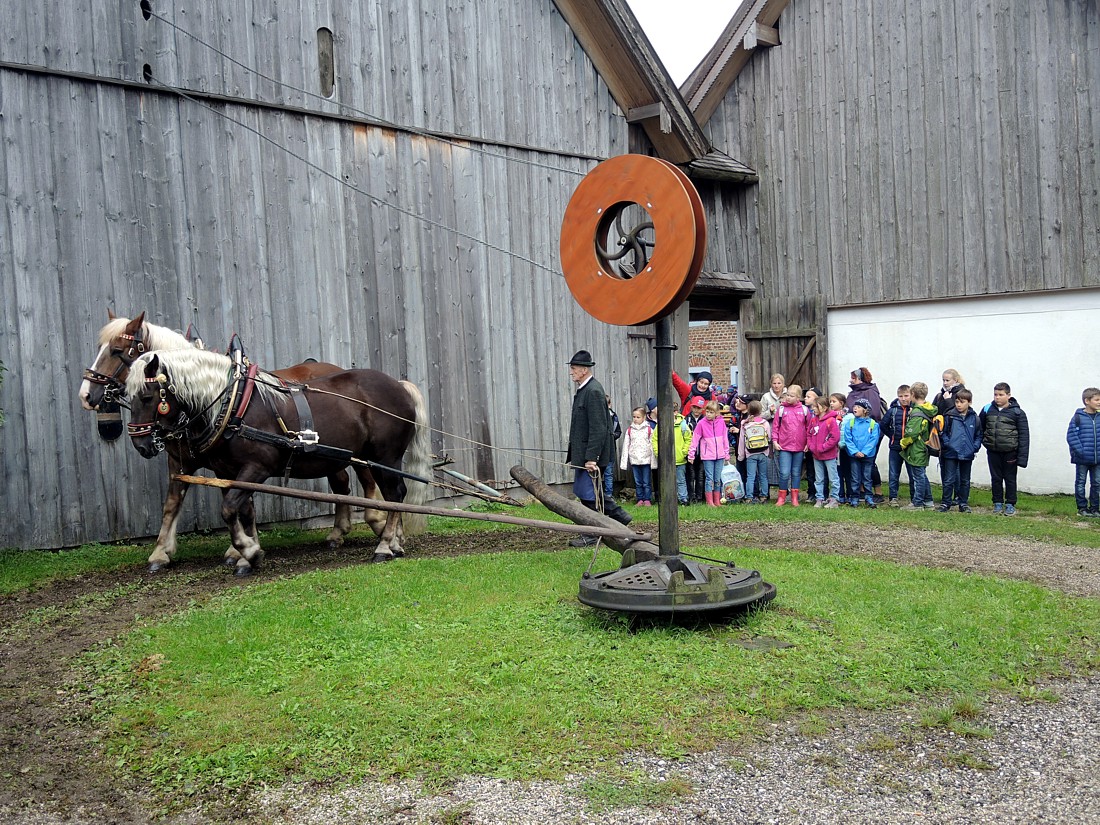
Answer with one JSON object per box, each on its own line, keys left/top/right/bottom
{"left": 127, "top": 350, "right": 430, "bottom": 575}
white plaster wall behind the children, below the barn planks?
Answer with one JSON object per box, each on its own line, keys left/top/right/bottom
{"left": 828, "top": 289, "right": 1100, "bottom": 493}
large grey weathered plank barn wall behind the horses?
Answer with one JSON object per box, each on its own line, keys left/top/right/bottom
{"left": 0, "top": 0, "right": 652, "bottom": 556}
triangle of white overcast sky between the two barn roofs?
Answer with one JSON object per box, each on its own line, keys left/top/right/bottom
{"left": 627, "top": 0, "right": 741, "bottom": 86}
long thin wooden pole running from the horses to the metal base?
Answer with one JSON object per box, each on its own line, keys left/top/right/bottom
{"left": 173, "top": 474, "right": 652, "bottom": 552}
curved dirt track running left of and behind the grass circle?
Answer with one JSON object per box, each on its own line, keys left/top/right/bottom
{"left": 0, "top": 523, "right": 1100, "bottom": 825}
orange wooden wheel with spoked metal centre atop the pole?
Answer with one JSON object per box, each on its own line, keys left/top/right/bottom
{"left": 560, "top": 155, "right": 706, "bottom": 326}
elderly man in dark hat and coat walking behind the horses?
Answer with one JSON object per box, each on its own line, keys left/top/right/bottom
{"left": 565, "top": 350, "right": 630, "bottom": 547}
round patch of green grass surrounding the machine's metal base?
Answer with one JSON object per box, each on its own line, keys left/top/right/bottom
{"left": 87, "top": 548, "right": 1100, "bottom": 793}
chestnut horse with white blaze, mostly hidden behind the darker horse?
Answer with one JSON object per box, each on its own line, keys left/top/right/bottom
{"left": 80, "top": 310, "right": 367, "bottom": 572}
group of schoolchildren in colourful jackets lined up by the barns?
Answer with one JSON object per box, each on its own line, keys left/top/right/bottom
{"left": 620, "top": 374, "right": 1100, "bottom": 517}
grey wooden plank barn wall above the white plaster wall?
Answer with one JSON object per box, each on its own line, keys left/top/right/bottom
{"left": 703, "top": 0, "right": 1100, "bottom": 393}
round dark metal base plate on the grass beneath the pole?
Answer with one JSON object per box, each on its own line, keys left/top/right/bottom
{"left": 578, "top": 556, "right": 776, "bottom": 615}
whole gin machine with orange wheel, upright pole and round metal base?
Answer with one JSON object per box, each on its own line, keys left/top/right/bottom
{"left": 550, "top": 155, "right": 776, "bottom": 618}
